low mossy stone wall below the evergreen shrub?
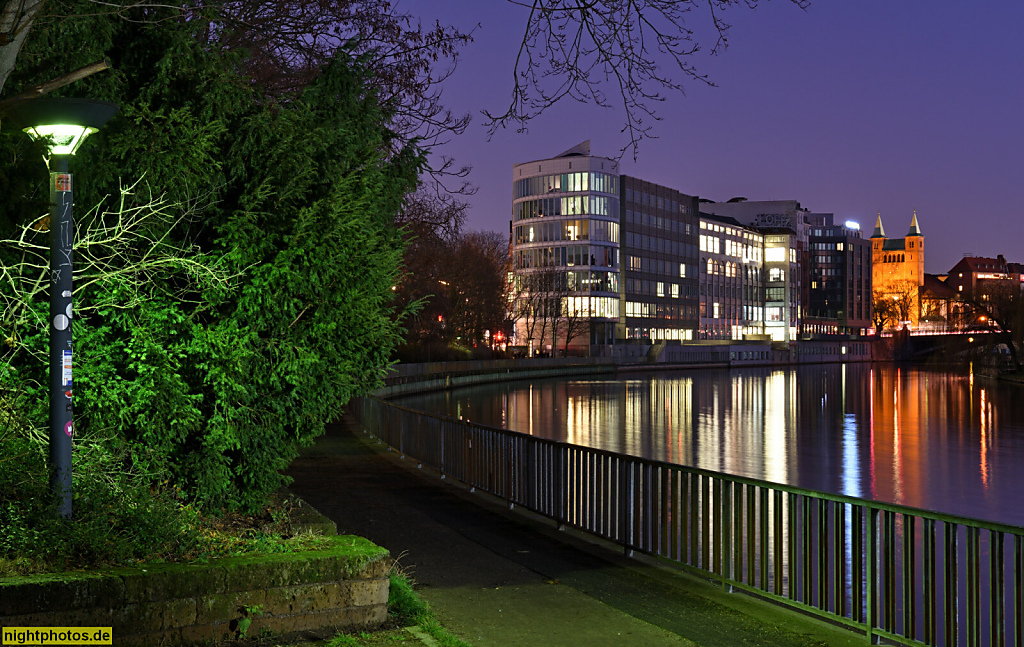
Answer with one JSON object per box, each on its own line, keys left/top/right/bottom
{"left": 0, "top": 535, "right": 389, "bottom": 645}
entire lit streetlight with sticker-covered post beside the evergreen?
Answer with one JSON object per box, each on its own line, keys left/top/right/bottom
{"left": 4, "top": 98, "right": 118, "bottom": 517}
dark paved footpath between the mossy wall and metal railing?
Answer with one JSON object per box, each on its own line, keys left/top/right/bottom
{"left": 289, "top": 417, "right": 865, "bottom": 647}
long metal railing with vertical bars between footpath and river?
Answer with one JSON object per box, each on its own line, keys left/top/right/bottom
{"left": 354, "top": 397, "right": 1024, "bottom": 647}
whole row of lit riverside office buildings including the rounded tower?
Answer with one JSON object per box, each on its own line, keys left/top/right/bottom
{"left": 511, "top": 141, "right": 872, "bottom": 353}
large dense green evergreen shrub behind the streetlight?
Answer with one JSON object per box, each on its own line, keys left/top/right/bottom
{"left": 0, "top": 3, "right": 423, "bottom": 515}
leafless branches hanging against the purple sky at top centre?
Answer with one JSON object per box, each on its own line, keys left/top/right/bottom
{"left": 484, "top": 0, "right": 809, "bottom": 158}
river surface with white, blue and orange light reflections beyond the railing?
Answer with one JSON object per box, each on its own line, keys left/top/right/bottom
{"left": 400, "top": 364, "right": 1024, "bottom": 525}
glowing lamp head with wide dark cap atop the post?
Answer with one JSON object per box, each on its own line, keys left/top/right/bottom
{"left": 4, "top": 98, "right": 118, "bottom": 155}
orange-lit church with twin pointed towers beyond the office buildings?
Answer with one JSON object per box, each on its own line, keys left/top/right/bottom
{"left": 871, "top": 211, "right": 925, "bottom": 329}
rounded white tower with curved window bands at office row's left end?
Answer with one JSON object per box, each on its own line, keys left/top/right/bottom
{"left": 512, "top": 141, "right": 622, "bottom": 351}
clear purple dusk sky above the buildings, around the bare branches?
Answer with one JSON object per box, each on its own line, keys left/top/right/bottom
{"left": 396, "top": 0, "right": 1024, "bottom": 273}
